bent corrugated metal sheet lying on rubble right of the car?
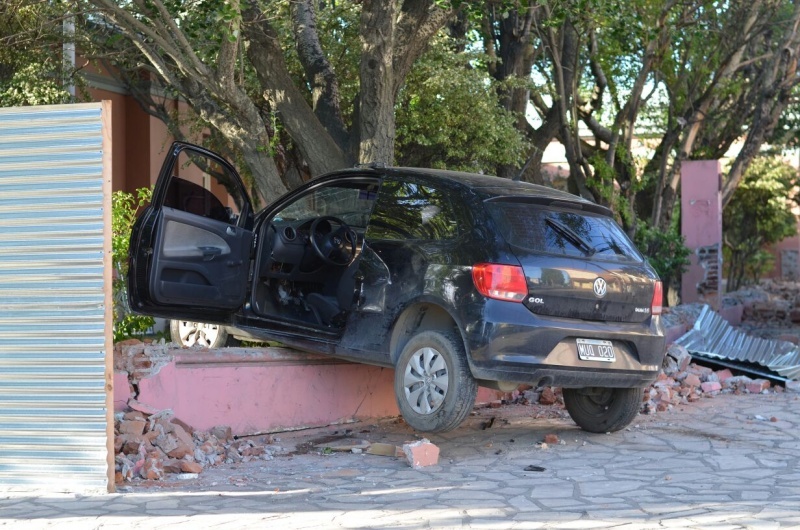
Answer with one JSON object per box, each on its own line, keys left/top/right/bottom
{"left": 675, "top": 306, "right": 800, "bottom": 379}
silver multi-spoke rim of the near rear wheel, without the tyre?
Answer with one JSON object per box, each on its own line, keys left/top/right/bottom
{"left": 403, "top": 347, "right": 449, "bottom": 415}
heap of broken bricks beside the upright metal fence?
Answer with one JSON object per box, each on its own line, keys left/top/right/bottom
{"left": 114, "top": 404, "right": 283, "bottom": 484}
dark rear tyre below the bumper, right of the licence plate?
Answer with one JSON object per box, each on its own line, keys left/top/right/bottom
{"left": 562, "top": 388, "right": 642, "bottom": 433}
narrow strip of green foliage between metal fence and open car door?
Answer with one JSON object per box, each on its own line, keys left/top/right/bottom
{"left": 111, "top": 188, "right": 155, "bottom": 341}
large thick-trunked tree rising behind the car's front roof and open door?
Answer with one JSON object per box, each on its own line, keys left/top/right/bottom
{"left": 86, "top": 0, "right": 455, "bottom": 197}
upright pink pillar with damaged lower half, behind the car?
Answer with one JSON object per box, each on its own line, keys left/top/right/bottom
{"left": 681, "top": 160, "right": 722, "bottom": 309}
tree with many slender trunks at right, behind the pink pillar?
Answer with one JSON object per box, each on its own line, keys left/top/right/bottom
{"left": 480, "top": 0, "right": 800, "bottom": 232}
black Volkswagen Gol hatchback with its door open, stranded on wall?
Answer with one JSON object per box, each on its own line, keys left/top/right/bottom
{"left": 128, "top": 142, "right": 665, "bottom": 432}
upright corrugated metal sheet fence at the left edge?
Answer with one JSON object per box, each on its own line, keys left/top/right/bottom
{"left": 0, "top": 103, "right": 108, "bottom": 491}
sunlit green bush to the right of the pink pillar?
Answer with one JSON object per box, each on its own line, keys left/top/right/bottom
{"left": 722, "top": 157, "right": 797, "bottom": 291}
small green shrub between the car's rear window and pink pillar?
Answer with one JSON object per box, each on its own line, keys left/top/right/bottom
{"left": 635, "top": 219, "right": 691, "bottom": 304}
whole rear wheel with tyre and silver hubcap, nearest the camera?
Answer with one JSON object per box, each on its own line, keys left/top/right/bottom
{"left": 394, "top": 331, "right": 478, "bottom": 432}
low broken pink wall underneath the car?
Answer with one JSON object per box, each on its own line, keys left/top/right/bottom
{"left": 114, "top": 348, "right": 498, "bottom": 434}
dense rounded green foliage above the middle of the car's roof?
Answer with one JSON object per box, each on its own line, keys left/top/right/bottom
{"left": 395, "top": 39, "right": 529, "bottom": 173}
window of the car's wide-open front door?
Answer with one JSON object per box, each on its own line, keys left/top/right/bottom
{"left": 164, "top": 149, "right": 245, "bottom": 225}
